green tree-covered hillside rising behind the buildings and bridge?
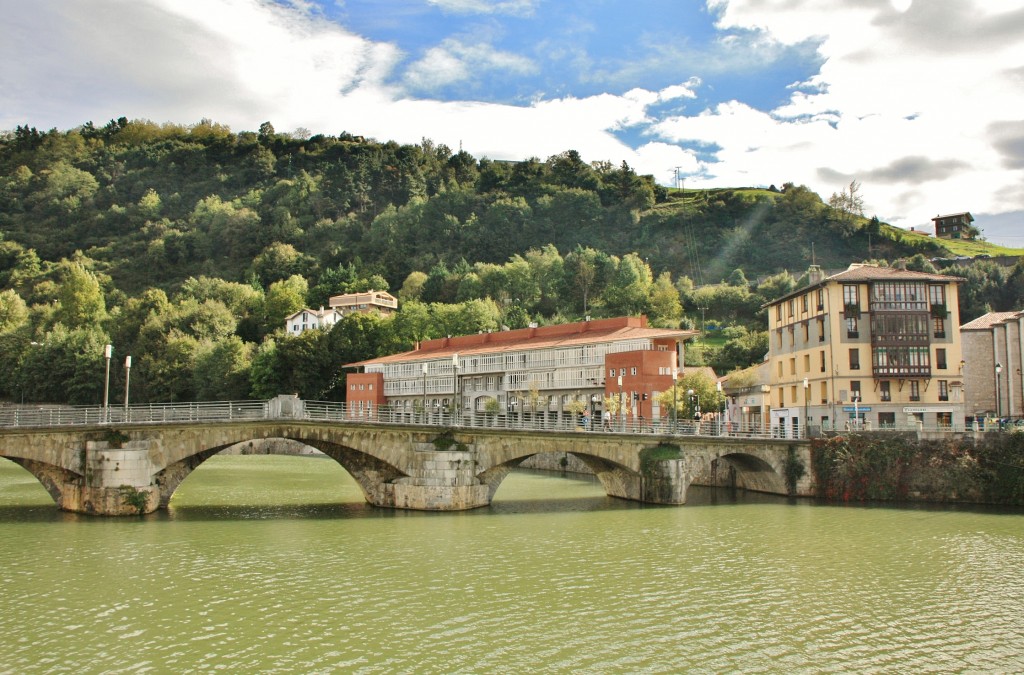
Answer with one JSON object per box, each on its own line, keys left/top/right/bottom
{"left": 0, "top": 118, "right": 1022, "bottom": 404}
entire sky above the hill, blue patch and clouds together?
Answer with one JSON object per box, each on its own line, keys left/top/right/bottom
{"left": 6, "top": 0, "right": 1024, "bottom": 247}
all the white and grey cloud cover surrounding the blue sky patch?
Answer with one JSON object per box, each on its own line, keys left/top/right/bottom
{"left": 0, "top": 0, "right": 1024, "bottom": 240}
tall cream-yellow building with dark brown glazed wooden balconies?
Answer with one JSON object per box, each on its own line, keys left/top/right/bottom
{"left": 766, "top": 264, "right": 964, "bottom": 436}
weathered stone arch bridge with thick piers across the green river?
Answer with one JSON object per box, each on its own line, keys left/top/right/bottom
{"left": 0, "top": 399, "right": 813, "bottom": 515}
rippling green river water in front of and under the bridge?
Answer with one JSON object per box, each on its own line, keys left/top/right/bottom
{"left": 0, "top": 457, "right": 1024, "bottom": 673}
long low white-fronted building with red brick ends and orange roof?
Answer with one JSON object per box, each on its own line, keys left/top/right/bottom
{"left": 346, "top": 317, "right": 697, "bottom": 420}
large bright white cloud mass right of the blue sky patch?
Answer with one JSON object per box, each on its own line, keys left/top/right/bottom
{"left": 655, "top": 0, "right": 1024, "bottom": 225}
